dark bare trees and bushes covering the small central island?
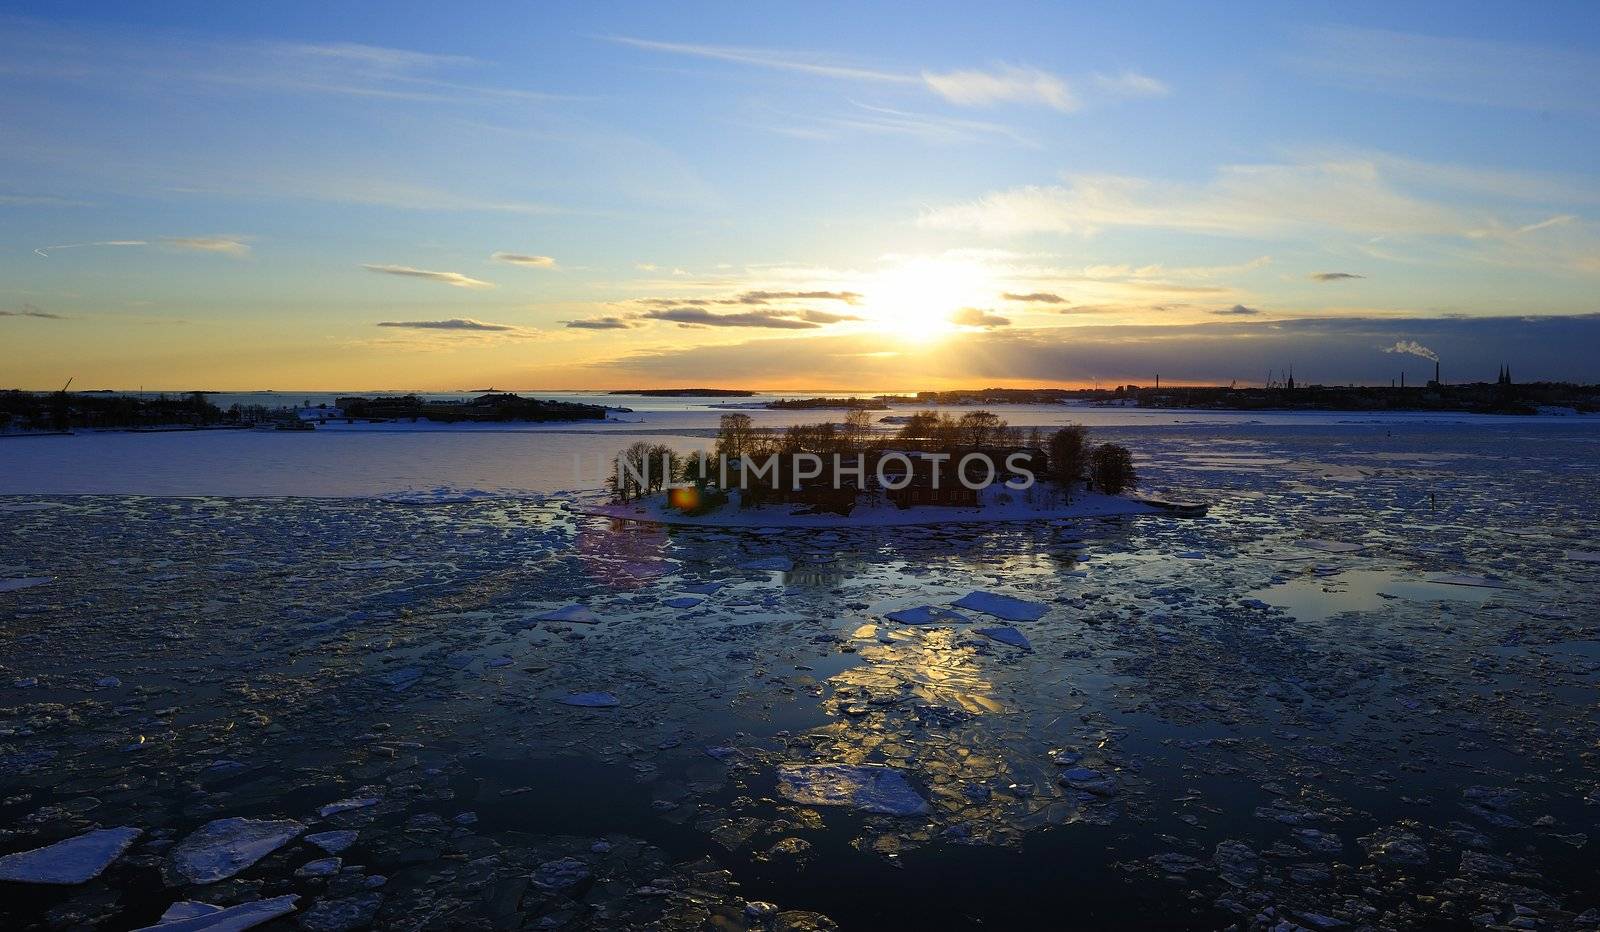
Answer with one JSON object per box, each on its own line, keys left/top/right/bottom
{"left": 608, "top": 410, "right": 1138, "bottom": 514}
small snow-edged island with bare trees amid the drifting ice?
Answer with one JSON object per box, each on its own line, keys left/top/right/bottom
{"left": 581, "top": 412, "right": 1157, "bottom": 527}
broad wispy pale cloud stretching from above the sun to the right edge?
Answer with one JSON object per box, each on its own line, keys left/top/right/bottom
{"left": 918, "top": 155, "right": 1600, "bottom": 272}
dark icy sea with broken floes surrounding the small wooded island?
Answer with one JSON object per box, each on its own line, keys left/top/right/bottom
{"left": 0, "top": 409, "right": 1600, "bottom": 929}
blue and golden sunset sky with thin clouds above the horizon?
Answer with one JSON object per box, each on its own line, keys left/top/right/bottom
{"left": 0, "top": 0, "right": 1600, "bottom": 391}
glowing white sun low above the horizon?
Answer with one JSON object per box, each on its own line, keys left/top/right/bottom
{"left": 862, "top": 258, "right": 997, "bottom": 343}
